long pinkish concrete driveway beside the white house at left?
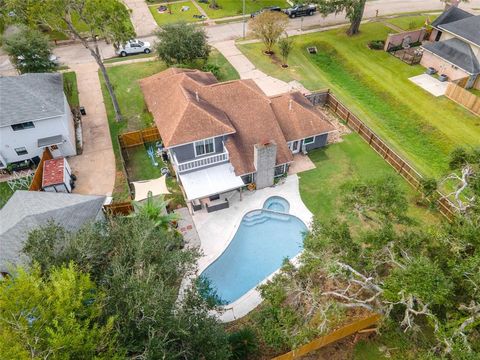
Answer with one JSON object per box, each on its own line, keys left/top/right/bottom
{"left": 68, "top": 63, "right": 116, "bottom": 195}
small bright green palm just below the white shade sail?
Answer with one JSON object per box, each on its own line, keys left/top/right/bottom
{"left": 130, "top": 191, "right": 179, "bottom": 229}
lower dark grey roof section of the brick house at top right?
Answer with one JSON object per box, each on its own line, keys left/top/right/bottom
{"left": 423, "top": 38, "right": 480, "bottom": 74}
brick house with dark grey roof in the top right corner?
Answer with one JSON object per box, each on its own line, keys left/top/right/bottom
{"left": 420, "top": 6, "right": 480, "bottom": 88}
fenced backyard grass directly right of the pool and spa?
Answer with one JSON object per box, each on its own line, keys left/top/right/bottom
{"left": 299, "top": 133, "right": 436, "bottom": 223}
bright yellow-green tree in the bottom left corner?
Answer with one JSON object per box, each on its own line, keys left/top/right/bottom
{"left": 0, "top": 264, "right": 123, "bottom": 360}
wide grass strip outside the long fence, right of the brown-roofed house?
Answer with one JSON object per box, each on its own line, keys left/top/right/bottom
{"left": 239, "top": 23, "right": 480, "bottom": 177}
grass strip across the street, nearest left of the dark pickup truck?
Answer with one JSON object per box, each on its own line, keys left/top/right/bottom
{"left": 197, "top": 0, "right": 290, "bottom": 19}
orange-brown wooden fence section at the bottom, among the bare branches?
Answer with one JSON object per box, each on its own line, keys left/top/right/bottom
{"left": 272, "top": 314, "right": 381, "bottom": 360}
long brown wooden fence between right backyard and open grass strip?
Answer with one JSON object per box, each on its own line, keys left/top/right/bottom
{"left": 326, "top": 89, "right": 456, "bottom": 220}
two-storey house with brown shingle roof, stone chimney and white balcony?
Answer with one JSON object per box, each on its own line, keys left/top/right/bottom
{"left": 140, "top": 68, "right": 336, "bottom": 209}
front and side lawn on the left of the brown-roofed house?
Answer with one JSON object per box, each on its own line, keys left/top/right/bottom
{"left": 99, "top": 51, "right": 239, "bottom": 201}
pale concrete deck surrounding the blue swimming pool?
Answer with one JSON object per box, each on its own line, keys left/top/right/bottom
{"left": 193, "top": 174, "right": 313, "bottom": 322}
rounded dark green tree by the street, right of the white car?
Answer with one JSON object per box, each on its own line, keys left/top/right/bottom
{"left": 155, "top": 22, "right": 210, "bottom": 65}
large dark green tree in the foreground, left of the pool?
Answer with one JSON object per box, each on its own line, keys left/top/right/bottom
{"left": 25, "top": 212, "right": 230, "bottom": 359}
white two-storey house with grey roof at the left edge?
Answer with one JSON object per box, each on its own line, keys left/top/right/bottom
{"left": 0, "top": 74, "right": 76, "bottom": 169}
